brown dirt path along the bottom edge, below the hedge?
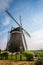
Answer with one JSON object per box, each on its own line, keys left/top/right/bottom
{"left": 0, "top": 60, "right": 34, "bottom": 65}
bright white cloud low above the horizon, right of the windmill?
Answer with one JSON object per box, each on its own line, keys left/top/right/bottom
{"left": 26, "top": 30, "right": 43, "bottom": 50}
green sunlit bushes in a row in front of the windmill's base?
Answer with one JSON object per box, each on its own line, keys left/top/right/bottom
{"left": 0, "top": 51, "right": 33, "bottom": 61}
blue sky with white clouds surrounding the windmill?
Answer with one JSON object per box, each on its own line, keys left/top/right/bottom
{"left": 0, "top": 0, "right": 43, "bottom": 49}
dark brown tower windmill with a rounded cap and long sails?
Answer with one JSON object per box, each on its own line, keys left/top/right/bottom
{"left": 5, "top": 10, "right": 31, "bottom": 52}
